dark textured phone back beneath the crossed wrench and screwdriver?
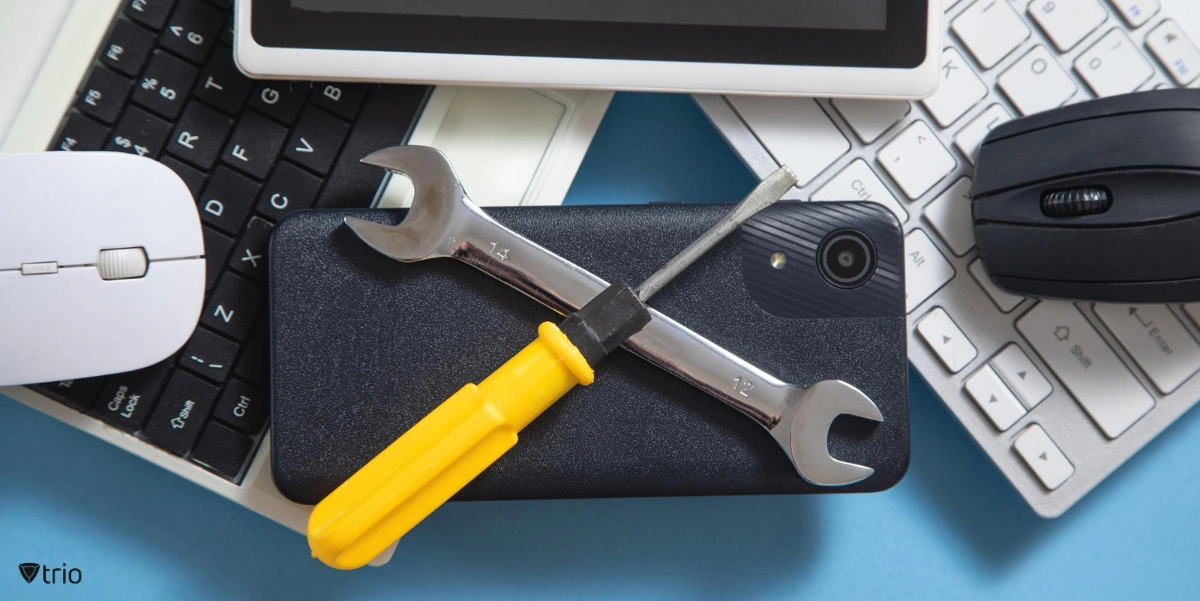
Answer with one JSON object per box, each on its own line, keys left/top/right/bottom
{"left": 269, "top": 203, "right": 908, "bottom": 504}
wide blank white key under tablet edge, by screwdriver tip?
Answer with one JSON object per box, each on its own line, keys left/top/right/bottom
{"left": 727, "top": 96, "right": 850, "bottom": 186}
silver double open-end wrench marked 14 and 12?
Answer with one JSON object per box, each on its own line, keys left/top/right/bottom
{"left": 346, "top": 146, "right": 883, "bottom": 486}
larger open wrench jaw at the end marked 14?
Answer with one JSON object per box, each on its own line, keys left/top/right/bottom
{"left": 344, "top": 146, "right": 478, "bottom": 263}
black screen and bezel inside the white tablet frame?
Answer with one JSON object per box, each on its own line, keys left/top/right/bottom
{"left": 253, "top": 0, "right": 936, "bottom": 68}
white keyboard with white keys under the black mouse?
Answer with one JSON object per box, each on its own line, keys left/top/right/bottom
{"left": 696, "top": 0, "right": 1200, "bottom": 517}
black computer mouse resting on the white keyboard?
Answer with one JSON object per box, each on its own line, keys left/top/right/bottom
{"left": 971, "top": 90, "right": 1200, "bottom": 302}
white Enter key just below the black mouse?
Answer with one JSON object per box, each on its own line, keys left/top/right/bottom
{"left": 1094, "top": 303, "right": 1200, "bottom": 395}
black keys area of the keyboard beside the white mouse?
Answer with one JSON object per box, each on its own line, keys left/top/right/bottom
{"left": 31, "top": 0, "right": 430, "bottom": 482}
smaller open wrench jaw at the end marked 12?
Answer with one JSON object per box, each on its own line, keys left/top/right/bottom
{"left": 772, "top": 380, "right": 883, "bottom": 486}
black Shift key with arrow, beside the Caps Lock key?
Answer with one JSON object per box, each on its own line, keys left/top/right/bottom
{"left": 142, "top": 371, "right": 217, "bottom": 456}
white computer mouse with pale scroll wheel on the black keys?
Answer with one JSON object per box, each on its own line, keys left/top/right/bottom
{"left": 0, "top": 152, "right": 204, "bottom": 386}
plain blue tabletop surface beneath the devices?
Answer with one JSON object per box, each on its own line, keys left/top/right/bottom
{"left": 0, "top": 95, "right": 1200, "bottom": 600}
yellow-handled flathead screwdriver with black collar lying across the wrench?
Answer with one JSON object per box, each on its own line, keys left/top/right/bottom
{"left": 308, "top": 166, "right": 796, "bottom": 570}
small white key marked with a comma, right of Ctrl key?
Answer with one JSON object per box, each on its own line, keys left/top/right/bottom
{"left": 873, "top": 121, "right": 958, "bottom": 200}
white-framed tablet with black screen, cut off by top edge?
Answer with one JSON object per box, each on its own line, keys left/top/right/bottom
{"left": 234, "top": 0, "right": 942, "bottom": 98}
